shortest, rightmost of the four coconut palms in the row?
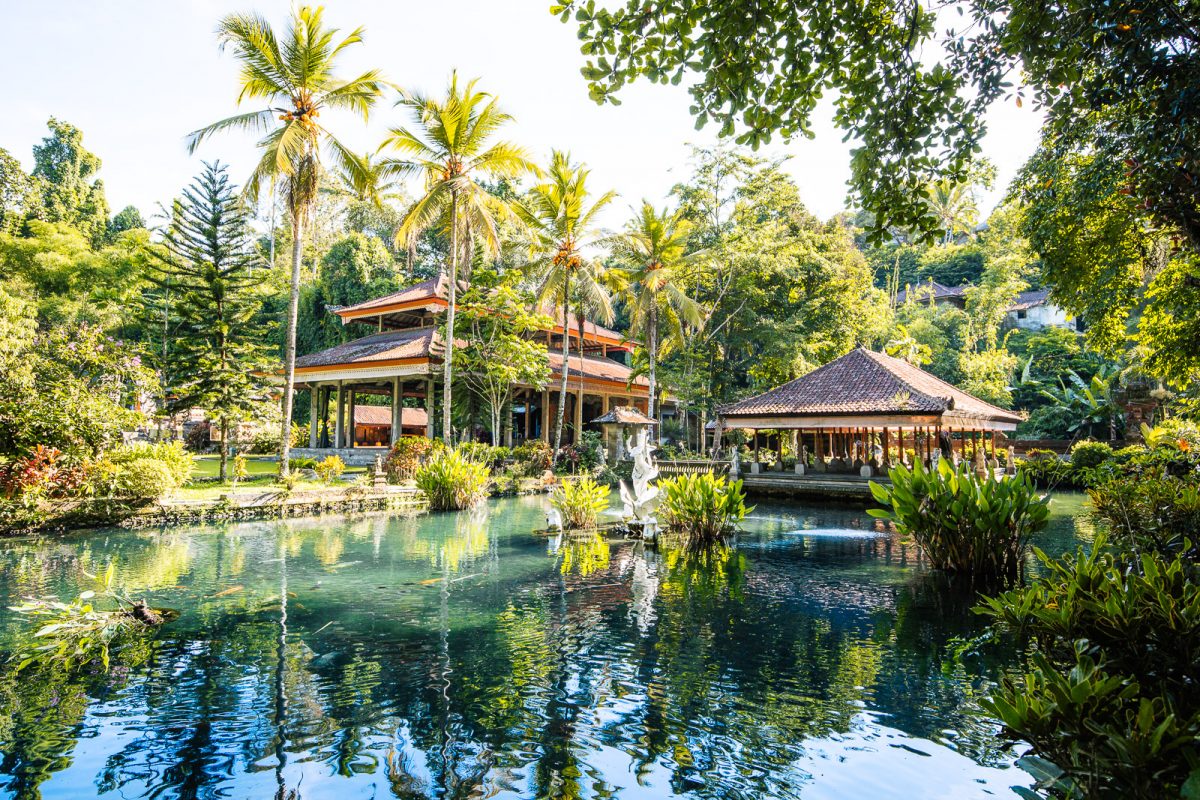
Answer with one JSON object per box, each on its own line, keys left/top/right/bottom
{"left": 608, "top": 200, "right": 702, "bottom": 416}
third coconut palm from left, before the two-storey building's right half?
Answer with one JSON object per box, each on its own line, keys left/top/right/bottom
{"left": 518, "top": 150, "right": 617, "bottom": 451}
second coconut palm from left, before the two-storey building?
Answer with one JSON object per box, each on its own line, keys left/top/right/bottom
{"left": 380, "top": 73, "right": 538, "bottom": 444}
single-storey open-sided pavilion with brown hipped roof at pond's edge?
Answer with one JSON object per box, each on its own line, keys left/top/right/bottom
{"left": 714, "top": 347, "right": 1021, "bottom": 477}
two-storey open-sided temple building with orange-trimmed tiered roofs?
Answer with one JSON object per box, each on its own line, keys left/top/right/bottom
{"left": 294, "top": 276, "right": 673, "bottom": 462}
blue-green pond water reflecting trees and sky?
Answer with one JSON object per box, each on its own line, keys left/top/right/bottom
{"left": 0, "top": 498, "right": 1094, "bottom": 800}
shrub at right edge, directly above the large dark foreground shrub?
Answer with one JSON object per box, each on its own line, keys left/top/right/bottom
{"left": 1087, "top": 475, "right": 1200, "bottom": 554}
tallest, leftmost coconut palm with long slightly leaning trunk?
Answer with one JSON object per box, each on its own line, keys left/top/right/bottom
{"left": 187, "top": 6, "right": 386, "bottom": 475}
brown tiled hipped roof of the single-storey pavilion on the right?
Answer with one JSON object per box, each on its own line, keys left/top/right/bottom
{"left": 720, "top": 347, "right": 1021, "bottom": 423}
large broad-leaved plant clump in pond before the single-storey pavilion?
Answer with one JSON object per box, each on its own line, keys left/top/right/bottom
{"left": 868, "top": 459, "right": 1050, "bottom": 578}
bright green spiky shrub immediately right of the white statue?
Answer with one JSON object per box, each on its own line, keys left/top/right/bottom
{"left": 658, "top": 473, "right": 754, "bottom": 543}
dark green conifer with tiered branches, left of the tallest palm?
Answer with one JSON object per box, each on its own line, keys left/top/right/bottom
{"left": 152, "top": 163, "right": 268, "bottom": 481}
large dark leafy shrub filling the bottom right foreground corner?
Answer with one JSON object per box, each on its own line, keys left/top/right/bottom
{"left": 978, "top": 537, "right": 1200, "bottom": 798}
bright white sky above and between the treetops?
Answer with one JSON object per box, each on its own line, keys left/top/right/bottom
{"left": 0, "top": 0, "right": 1039, "bottom": 228}
